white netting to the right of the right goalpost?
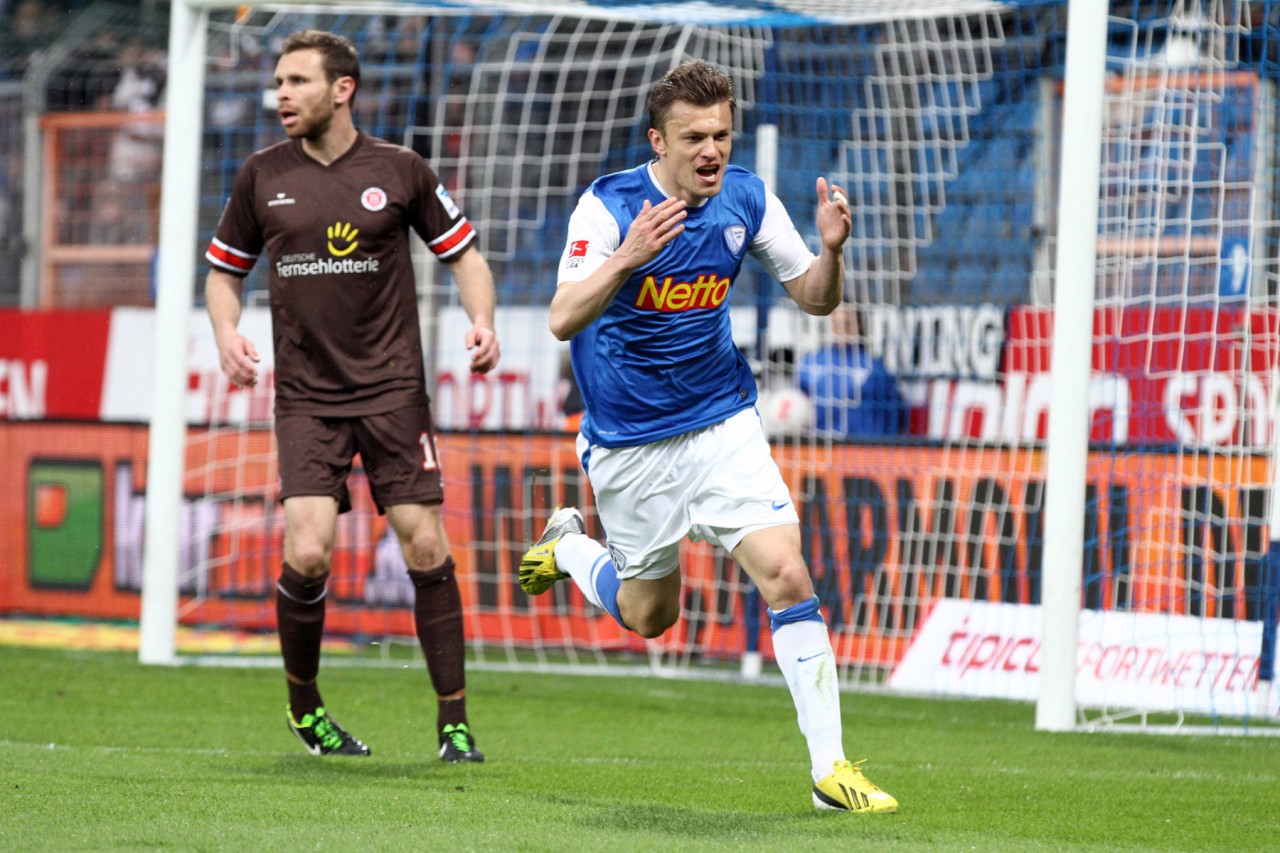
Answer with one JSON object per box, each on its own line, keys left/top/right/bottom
{"left": 1078, "top": 3, "right": 1277, "bottom": 725}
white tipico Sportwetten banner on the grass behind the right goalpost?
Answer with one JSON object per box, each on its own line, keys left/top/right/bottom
{"left": 888, "top": 599, "right": 1280, "bottom": 717}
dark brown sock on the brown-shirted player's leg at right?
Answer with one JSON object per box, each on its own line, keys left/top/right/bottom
{"left": 408, "top": 557, "right": 467, "bottom": 727}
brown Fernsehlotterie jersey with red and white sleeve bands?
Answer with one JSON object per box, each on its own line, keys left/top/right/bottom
{"left": 205, "top": 133, "right": 475, "bottom": 416}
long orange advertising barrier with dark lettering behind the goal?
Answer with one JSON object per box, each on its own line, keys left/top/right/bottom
{"left": 0, "top": 423, "right": 1266, "bottom": 665}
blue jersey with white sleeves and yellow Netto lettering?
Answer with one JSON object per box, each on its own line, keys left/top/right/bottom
{"left": 562, "top": 167, "right": 813, "bottom": 447}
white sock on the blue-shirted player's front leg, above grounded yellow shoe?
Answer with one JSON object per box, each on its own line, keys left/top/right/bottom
{"left": 773, "top": 620, "right": 845, "bottom": 781}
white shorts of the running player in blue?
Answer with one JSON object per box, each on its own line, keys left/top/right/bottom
{"left": 577, "top": 409, "right": 800, "bottom": 580}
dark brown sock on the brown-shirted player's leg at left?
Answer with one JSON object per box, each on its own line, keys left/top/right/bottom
{"left": 275, "top": 564, "right": 329, "bottom": 720}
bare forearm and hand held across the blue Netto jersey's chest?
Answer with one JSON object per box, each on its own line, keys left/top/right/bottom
{"left": 549, "top": 199, "right": 687, "bottom": 341}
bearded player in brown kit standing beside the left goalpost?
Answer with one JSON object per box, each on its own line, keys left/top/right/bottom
{"left": 205, "top": 29, "right": 499, "bottom": 762}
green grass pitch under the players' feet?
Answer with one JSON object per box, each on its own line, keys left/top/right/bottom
{"left": 0, "top": 647, "right": 1280, "bottom": 853}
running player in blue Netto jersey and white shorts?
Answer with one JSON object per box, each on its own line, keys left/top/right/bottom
{"left": 520, "top": 61, "right": 897, "bottom": 813}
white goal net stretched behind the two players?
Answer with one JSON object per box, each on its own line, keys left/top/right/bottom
{"left": 148, "top": 0, "right": 1280, "bottom": 725}
